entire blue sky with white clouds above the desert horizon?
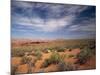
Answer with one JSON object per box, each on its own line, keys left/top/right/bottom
{"left": 11, "top": 1, "right": 96, "bottom": 39}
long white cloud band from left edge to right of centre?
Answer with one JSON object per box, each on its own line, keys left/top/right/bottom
{"left": 12, "top": 16, "right": 74, "bottom": 32}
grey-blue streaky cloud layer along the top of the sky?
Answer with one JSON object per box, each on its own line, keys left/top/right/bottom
{"left": 12, "top": 1, "right": 88, "bottom": 18}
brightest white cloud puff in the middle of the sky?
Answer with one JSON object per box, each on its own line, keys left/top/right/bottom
{"left": 37, "top": 16, "right": 73, "bottom": 32}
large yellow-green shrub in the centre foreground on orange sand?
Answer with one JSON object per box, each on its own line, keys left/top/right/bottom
{"left": 42, "top": 52, "right": 65, "bottom": 67}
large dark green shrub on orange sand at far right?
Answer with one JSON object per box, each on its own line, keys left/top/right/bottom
{"left": 76, "top": 47, "right": 94, "bottom": 64}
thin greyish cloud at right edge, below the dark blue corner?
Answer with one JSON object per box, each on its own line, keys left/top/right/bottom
{"left": 68, "top": 18, "right": 96, "bottom": 32}
